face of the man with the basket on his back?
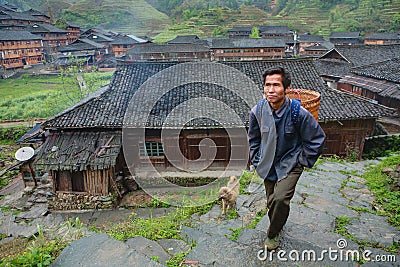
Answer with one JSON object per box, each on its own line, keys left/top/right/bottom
{"left": 264, "top": 74, "right": 289, "bottom": 106}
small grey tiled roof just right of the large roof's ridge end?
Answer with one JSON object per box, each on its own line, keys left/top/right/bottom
{"left": 314, "top": 59, "right": 350, "bottom": 78}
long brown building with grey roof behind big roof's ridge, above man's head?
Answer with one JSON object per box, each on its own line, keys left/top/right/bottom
{"left": 209, "top": 38, "right": 287, "bottom": 61}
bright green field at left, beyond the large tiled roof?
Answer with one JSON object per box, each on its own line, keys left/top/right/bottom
{"left": 0, "top": 72, "right": 112, "bottom": 120}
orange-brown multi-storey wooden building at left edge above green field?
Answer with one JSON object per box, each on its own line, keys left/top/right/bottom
{"left": 0, "top": 30, "right": 43, "bottom": 70}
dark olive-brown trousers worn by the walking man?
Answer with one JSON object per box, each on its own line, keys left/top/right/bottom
{"left": 264, "top": 164, "right": 303, "bottom": 238}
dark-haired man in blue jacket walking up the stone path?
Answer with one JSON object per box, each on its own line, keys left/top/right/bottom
{"left": 248, "top": 67, "right": 325, "bottom": 250}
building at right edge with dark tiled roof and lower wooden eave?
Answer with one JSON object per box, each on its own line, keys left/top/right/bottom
{"left": 338, "top": 57, "right": 400, "bottom": 114}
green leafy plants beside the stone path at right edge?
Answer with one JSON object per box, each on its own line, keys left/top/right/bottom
{"left": 362, "top": 155, "right": 400, "bottom": 229}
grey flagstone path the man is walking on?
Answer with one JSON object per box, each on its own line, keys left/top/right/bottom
{"left": 2, "top": 161, "right": 400, "bottom": 267}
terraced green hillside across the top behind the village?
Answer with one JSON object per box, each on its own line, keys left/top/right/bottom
{"left": 0, "top": 0, "right": 400, "bottom": 41}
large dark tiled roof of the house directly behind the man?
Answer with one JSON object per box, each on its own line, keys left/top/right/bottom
{"left": 44, "top": 59, "right": 391, "bottom": 131}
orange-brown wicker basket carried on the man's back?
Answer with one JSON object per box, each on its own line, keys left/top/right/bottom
{"left": 286, "top": 89, "right": 321, "bottom": 121}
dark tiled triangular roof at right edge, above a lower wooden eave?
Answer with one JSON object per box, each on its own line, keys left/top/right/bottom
{"left": 351, "top": 57, "right": 400, "bottom": 84}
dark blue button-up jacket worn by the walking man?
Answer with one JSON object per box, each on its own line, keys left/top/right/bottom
{"left": 248, "top": 98, "right": 325, "bottom": 180}
